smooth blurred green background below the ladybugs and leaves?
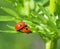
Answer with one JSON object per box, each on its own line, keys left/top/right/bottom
{"left": 0, "top": 33, "right": 45, "bottom": 49}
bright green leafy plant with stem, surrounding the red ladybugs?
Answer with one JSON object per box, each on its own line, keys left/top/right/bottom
{"left": 0, "top": 0, "right": 60, "bottom": 49}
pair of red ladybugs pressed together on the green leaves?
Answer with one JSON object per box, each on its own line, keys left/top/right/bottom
{"left": 15, "top": 22, "right": 31, "bottom": 33}
